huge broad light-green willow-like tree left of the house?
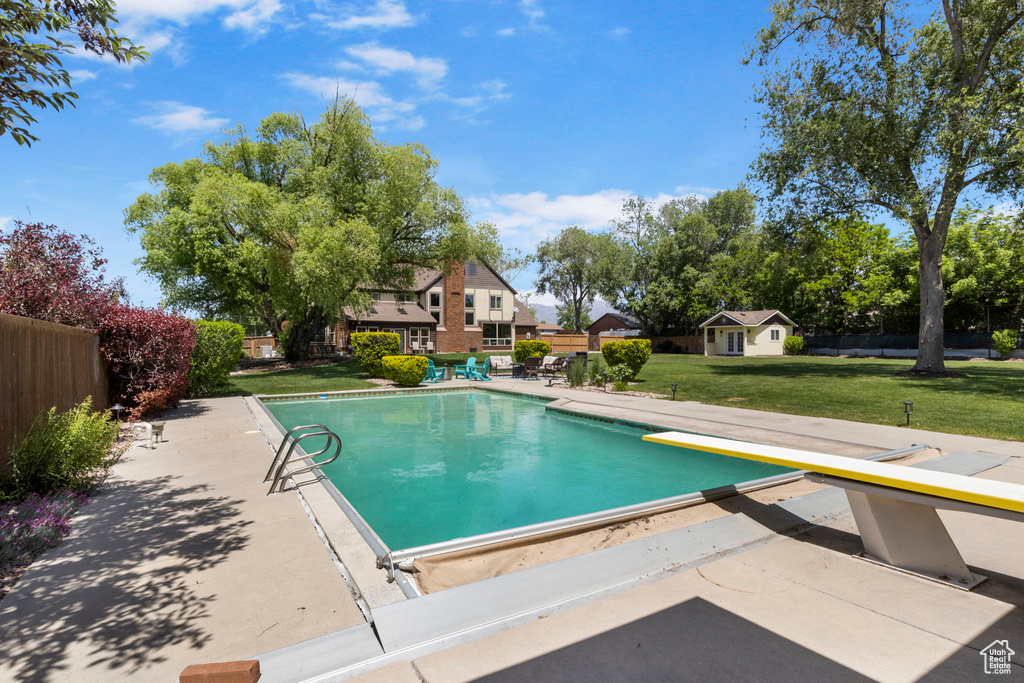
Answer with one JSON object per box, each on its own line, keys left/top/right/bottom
{"left": 125, "top": 101, "right": 498, "bottom": 359}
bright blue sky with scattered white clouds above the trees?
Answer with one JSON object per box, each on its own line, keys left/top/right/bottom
{"left": 0, "top": 0, "right": 766, "bottom": 304}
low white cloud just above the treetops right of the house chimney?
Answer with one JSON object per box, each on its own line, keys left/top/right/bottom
{"left": 469, "top": 188, "right": 704, "bottom": 246}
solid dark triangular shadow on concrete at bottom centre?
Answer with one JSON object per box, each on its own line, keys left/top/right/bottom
{"left": 477, "top": 598, "right": 871, "bottom": 683}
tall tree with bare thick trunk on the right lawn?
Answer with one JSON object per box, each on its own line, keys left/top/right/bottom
{"left": 749, "top": 0, "right": 1024, "bottom": 373}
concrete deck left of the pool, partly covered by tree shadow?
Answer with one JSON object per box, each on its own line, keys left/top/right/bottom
{"left": 0, "top": 398, "right": 365, "bottom": 683}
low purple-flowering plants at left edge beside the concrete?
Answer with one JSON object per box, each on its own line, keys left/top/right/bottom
{"left": 0, "top": 490, "right": 89, "bottom": 571}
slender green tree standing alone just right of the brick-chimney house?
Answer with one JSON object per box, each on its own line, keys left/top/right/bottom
{"left": 535, "top": 225, "right": 611, "bottom": 334}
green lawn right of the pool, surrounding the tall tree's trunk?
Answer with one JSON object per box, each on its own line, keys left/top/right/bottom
{"left": 631, "top": 354, "right": 1024, "bottom": 440}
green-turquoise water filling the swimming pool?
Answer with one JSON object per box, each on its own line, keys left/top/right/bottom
{"left": 266, "top": 390, "right": 787, "bottom": 550}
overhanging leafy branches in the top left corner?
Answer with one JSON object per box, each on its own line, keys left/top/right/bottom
{"left": 0, "top": 0, "right": 148, "bottom": 144}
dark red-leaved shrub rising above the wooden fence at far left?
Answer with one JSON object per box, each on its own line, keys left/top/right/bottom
{"left": 0, "top": 221, "right": 124, "bottom": 330}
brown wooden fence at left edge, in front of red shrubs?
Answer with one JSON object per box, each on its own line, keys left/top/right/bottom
{"left": 0, "top": 313, "right": 106, "bottom": 470}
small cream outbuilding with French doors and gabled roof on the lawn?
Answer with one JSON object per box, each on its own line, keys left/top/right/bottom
{"left": 700, "top": 309, "right": 797, "bottom": 355}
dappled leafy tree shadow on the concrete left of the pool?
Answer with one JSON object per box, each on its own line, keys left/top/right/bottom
{"left": 0, "top": 476, "right": 252, "bottom": 681}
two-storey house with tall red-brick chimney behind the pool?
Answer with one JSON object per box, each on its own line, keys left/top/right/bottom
{"left": 335, "top": 261, "right": 537, "bottom": 353}
